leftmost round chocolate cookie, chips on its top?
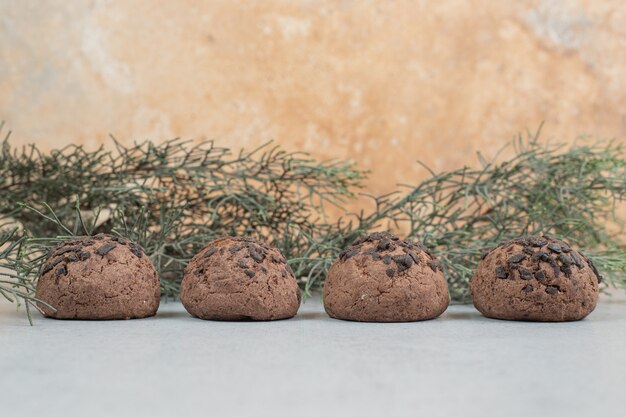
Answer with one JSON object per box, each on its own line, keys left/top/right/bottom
{"left": 35, "top": 234, "right": 160, "bottom": 320}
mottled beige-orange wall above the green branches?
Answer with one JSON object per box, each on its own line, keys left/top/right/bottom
{"left": 0, "top": 0, "right": 626, "bottom": 198}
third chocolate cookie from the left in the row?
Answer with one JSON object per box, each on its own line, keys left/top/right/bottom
{"left": 324, "top": 232, "right": 449, "bottom": 322}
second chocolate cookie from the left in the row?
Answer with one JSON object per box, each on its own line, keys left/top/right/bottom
{"left": 180, "top": 237, "right": 300, "bottom": 320}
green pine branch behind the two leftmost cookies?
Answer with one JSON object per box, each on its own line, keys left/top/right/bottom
{"left": 0, "top": 130, "right": 365, "bottom": 297}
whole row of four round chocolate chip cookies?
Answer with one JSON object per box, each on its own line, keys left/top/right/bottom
{"left": 36, "top": 232, "right": 601, "bottom": 322}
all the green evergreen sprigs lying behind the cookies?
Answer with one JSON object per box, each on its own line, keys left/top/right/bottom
{"left": 0, "top": 122, "right": 626, "bottom": 320}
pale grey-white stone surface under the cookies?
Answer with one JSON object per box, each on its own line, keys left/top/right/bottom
{"left": 0, "top": 300, "right": 626, "bottom": 417}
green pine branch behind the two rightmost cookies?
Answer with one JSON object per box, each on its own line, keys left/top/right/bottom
{"left": 294, "top": 135, "right": 626, "bottom": 302}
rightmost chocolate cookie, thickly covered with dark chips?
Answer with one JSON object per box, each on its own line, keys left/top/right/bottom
{"left": 470, "top": 236, "right": 601, "bottom": 321}
